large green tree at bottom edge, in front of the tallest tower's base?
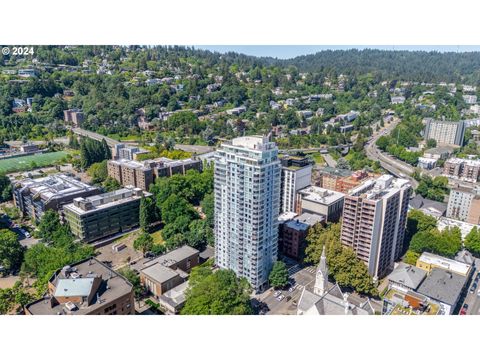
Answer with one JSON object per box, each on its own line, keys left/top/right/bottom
{"left": 181, "top": 268, "right": 253, "bottom": 315}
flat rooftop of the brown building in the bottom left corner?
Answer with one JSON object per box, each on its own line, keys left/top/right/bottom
{"left": 26, "top": 258, "right": 133, "bottom": 315}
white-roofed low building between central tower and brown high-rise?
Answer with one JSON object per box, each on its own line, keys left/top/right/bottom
{"left": 296, "top": 186, "right": 345, "bottom": 222}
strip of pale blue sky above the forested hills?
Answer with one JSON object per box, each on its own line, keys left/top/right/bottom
{"left": 195, "top": 45, "right": 480, "bottom": 59}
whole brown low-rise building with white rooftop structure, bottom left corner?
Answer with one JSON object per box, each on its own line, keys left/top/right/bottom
{"left": 25, "top": 258, "right": 135, "bottom": 315}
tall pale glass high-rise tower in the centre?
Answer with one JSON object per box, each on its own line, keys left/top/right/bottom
{"left": 215, "top": 136, "right": 281, "bottom": 291}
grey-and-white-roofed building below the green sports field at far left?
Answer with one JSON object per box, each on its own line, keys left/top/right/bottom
{"left": 13, "top": 174, "right": 101, "bottom": 222}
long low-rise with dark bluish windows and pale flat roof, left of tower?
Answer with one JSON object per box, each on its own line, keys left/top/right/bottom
{"left": 64, "top": 186, "right": 151, "bottom": 242}
